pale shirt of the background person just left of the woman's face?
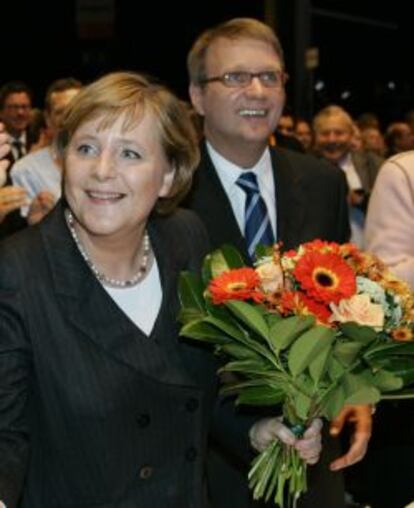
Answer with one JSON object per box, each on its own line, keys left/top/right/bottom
{"left": 10, "top": 147, "right": 62, "bottom": 217}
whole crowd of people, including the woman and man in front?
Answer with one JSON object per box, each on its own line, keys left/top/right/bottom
{"left": 0, "top": 13, "right": 414, "bottom": 508}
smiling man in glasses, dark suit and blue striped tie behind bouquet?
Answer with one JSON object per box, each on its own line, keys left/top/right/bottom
{"left": 187, "top": 19, "right": 371, "bottom": 508}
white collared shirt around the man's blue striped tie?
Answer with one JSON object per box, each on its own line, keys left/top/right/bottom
{"left": 206, "top": 141, "right": 277, "bottom": 238}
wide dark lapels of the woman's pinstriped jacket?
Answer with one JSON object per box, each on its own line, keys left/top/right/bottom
{"left": 42, "top": 202, "right": 196, "bottom": 384}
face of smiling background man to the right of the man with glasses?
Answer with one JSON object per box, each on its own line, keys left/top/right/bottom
{"left": 315, "top": 116, "right": 353, "bottom": 163}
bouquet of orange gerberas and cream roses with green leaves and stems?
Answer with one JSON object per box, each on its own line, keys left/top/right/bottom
{"left": 180, "top": 240, "right": 414, "bottom": 507}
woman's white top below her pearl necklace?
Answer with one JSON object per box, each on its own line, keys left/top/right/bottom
{"left": 102, "top": 259, "right": 162, "bottom": 338}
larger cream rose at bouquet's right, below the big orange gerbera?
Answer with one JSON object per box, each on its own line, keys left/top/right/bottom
{"left": 329, "top": 294, "right": 384, "bottom": 330}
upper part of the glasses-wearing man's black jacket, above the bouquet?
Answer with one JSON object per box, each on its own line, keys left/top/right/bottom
{"left": 185, "top": 144, "right": 350, "bottom": 256}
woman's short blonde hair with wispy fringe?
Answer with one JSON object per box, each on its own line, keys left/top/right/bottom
{"left": 57, "top": 72, "right": 200, "bottom": 214}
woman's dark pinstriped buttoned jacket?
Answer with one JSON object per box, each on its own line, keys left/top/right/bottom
{"left": 0, "top": 205, "right": 247, "bottom": 508}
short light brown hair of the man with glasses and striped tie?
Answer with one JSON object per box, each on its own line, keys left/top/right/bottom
{"left": 187, "top": 18, "right": 285, "bottom": 85}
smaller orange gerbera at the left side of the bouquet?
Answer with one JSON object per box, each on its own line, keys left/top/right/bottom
{"left": 208, "top": 268, "right": 263, "bottom": 305}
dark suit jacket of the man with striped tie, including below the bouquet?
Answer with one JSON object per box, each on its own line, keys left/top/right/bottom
{"left": 185, "top": 145, "right": 350, "bottom": 508}
